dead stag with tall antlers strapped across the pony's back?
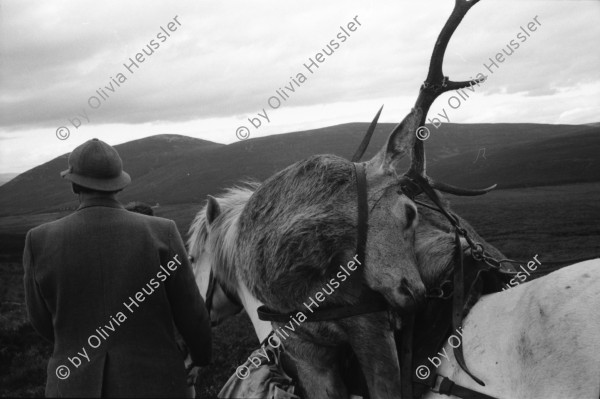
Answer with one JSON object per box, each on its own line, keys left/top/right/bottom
{"left": 185, "top": 0, "right": 597, "bottom": 399}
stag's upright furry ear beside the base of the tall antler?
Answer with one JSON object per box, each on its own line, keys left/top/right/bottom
{"left": 369, "top": 108, "right": 423, "bottom": 175}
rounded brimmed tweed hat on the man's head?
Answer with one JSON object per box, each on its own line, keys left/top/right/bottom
{"left": 60, "top": 139, "right": 131, "bottom": 191}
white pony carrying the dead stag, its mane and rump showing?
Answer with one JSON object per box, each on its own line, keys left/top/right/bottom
{"left": 188, "top": 189, "right": 600, "bottom": 399}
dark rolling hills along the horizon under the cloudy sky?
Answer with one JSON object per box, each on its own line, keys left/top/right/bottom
{"left": 0, "top": 123, "right": 600, "bottom": 216}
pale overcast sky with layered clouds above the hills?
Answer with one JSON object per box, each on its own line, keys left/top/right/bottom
{"left": 0, "top": 0, "right": 600, "bottom": 173}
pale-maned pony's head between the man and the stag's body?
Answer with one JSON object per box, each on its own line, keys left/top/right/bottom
{"left": 187, "top": 183, "right": 257, "bottom": 325}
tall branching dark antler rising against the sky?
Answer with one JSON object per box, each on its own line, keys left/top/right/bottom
{"left": 400, "top": 0, "right": 496, "bottom": 196}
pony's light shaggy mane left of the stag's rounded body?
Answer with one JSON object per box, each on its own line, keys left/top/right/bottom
{"left": 187, "top": 181, "right": 260, "bottom": 292}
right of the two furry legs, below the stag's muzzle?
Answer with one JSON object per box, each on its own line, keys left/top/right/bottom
{"left": 344, "top": 312, "right": 401, "bottom": 399}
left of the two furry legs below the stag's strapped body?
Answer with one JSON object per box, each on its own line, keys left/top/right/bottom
{"left": 285, "top": 336, "right": 348, "bottom": 399}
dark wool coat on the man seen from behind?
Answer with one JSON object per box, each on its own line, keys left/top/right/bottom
{"left": 23, "top": 198, "right": 211, "bottom": 397}
